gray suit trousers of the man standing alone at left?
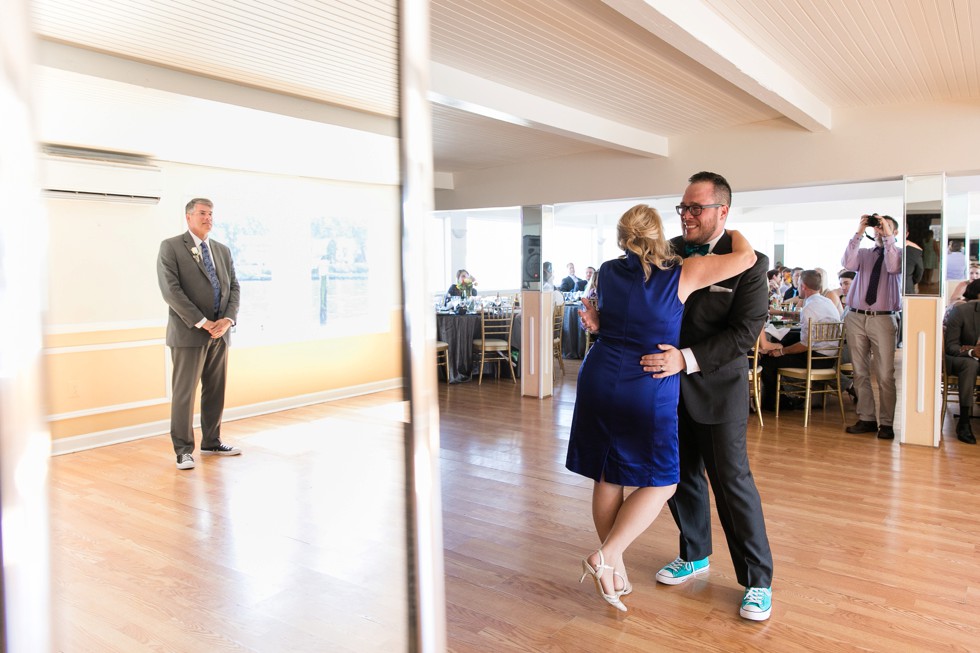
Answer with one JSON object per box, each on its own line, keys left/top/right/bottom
{"left": 170, "top": 338, "right": 228, "bottom": 456}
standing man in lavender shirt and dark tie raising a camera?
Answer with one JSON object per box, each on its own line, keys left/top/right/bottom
{"left": 841, "top": 213, "right": 902, "bottom": 440}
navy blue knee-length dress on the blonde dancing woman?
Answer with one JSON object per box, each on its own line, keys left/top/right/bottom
{"left": 565, "top": 253, "right": 684, "bottom": 487}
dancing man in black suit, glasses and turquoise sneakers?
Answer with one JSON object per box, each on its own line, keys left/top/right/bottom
{"left": 640, "top": 172, "right": 773, "bottom": 621}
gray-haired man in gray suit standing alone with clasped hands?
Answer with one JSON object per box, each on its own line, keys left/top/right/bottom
{"left": 157, "top": 197, "right": 242, "bottom": 469}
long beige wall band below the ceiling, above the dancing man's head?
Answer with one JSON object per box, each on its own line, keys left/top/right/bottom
{"left": 436, "top": 100, "right": 980, "bottom": 210}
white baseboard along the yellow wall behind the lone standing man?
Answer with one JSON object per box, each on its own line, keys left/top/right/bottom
{"left": 51, "top": 378, "right": 402, "bottom": 456}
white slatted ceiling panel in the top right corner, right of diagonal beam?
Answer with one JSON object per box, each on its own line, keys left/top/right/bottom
{"left": 704, "top": 0, "right": 980, "bottom": 107}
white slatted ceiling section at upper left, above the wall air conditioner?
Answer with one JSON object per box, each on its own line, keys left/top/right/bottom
{"left": 33, "top": 0, "right": 398, "bottom": 116}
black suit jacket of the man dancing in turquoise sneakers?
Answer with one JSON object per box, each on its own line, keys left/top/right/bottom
{"left": 670, "top": 232, "right": 769, "bottom": 424}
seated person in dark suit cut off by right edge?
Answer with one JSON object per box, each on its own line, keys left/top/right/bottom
{"left": 943, "top": 279, "right": 980, "bottom": 444}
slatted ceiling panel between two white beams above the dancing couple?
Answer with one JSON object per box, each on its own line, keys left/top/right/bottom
{"left": 432, "top": 0, "right": 777, "bottom": 136}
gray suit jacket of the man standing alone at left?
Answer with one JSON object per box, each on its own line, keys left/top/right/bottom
{"left": 157, "top": 231, "right": 240, "bottom": 347}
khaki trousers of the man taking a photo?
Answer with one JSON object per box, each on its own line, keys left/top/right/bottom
{"left": 844, "top": 311, "right": 898, "bottom": 426}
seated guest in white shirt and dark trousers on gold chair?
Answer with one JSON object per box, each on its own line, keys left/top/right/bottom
{"left": 759, "top": 270, "right": 840, "bottom": 410}
